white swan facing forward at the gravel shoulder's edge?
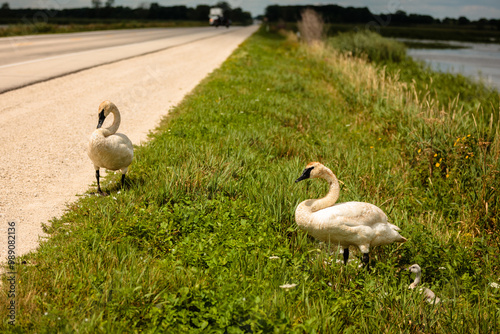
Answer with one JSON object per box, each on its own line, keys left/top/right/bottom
{"left": 87, "top": 101, "right": 134, "bottom": 194}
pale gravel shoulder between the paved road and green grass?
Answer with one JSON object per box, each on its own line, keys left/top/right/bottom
{"left": 0, "top": 26, "right": 257, "bottom": 261}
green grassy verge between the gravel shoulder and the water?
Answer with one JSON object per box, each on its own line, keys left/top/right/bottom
{"left": 0, "top": 26, "right": 500, "bottom": 333}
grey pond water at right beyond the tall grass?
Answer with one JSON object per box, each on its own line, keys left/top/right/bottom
{"left": 403, "top": 40, "right": 500, "bottom": 91}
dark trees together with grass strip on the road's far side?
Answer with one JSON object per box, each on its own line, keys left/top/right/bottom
{"left": 0, "top": 0, "right": 252, "bottom": 37}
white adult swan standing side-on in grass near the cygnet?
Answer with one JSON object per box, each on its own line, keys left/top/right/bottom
{"left": 295, "top": 162, "right": 406, "bottom": 267}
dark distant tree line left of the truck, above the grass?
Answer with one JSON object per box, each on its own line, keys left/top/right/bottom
{"left": 0, "top": 0, "right": 252, "bottom": 24}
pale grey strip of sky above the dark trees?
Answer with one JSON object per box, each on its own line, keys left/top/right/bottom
{"left": 8, "top": 0, "right": 500, "bottom": 20}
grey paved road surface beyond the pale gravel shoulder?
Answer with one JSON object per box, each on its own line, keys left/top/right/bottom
{"left": 0, "top": 27, "right": 236, "bottom": 93}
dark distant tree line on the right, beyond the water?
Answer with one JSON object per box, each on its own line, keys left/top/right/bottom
{"left": 265, "top": 5, "right": 500, "bottom": 30}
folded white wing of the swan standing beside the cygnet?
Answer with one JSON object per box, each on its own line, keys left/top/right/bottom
{"left": 313, "top": 202, "right": 387, "bottom": 227}
